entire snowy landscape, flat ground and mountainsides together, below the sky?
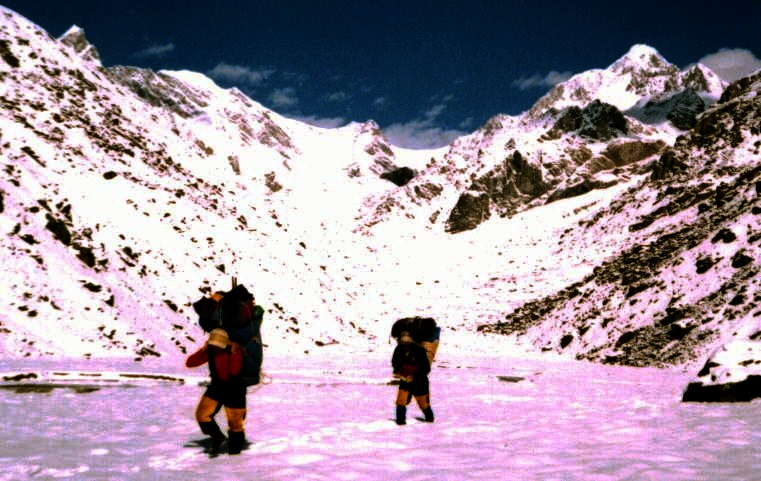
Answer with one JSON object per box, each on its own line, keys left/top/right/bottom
{"left": 0, "top": 7, "right": 761, "bottom": 481}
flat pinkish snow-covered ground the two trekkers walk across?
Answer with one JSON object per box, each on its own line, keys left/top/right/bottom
{"left": 0, "top": 344, "right": 761, "bottom": 481}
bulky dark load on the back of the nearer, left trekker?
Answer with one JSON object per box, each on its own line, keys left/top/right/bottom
{"left": 193, "top": 278, "right": 264, "bottom": 386}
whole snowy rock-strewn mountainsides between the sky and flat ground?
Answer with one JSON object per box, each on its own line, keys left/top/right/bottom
{"left": 0, "top": 4, "right": 759, "bottom": 372}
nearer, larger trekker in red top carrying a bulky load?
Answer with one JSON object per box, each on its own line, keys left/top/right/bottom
{"left": 185, "top": 278, "right": 264, "bottom": 455}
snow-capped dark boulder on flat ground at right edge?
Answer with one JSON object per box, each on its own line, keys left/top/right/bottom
{"left": 682, "top": 340, "right": 761, "bottom": 402}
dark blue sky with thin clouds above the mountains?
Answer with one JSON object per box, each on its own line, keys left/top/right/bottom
{"left": 0, "top": 0, "right": 761, "bottom": 146}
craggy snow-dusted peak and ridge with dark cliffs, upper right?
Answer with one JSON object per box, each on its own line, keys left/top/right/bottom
{"left": 356, "top": 45, "right": 725, "bottom": 233}
